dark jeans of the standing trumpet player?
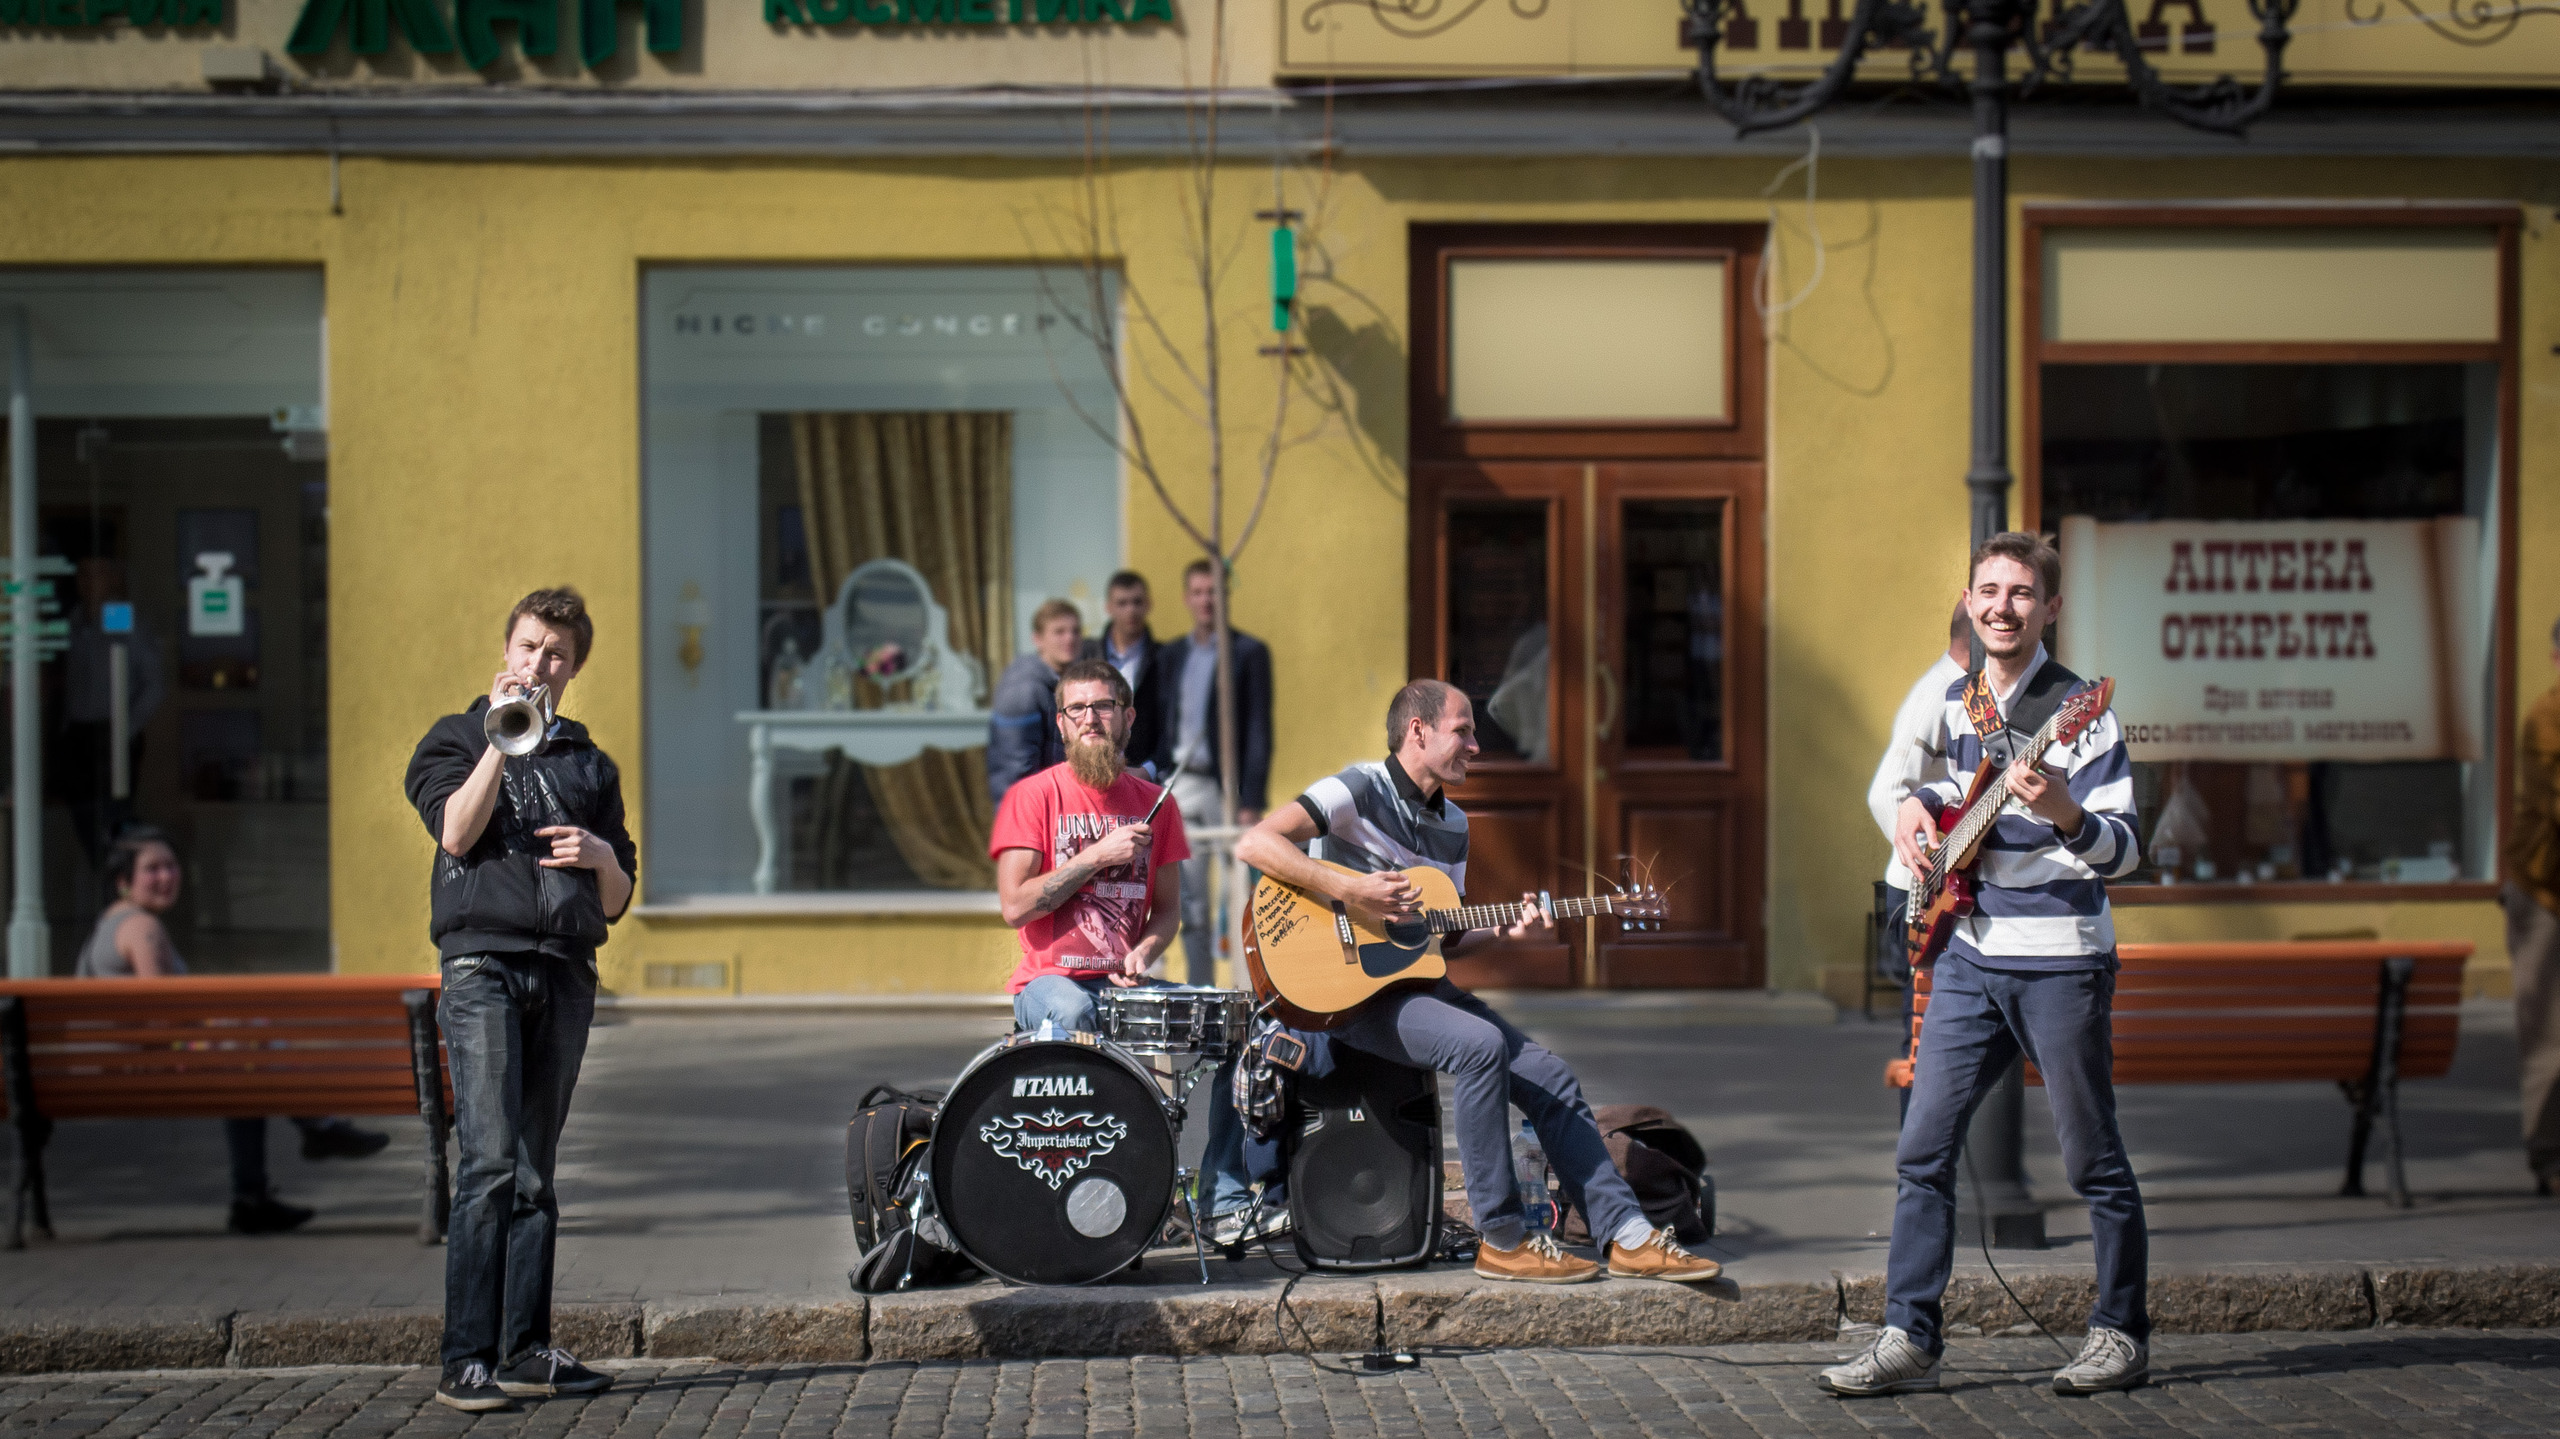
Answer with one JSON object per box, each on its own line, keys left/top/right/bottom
{"left": 435, "top": 953, "right": 596, "bottom": 1370}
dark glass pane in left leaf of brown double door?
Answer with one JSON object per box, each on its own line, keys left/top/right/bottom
{"left": 1446, "top": 499, "right": 1551, "bottom": 766}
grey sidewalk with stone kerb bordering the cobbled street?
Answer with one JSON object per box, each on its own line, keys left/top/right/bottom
{"left": 0, "top": 999, "right": 2560, "bottom": 1372}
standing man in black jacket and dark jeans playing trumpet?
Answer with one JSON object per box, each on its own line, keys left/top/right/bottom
{"left": 407, "top": 589, "right": 640, "bottom": 1411}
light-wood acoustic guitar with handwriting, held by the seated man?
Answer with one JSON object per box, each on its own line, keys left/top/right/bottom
{"left": 1244, "top": 860, "right": 1664, "bottom": 1029}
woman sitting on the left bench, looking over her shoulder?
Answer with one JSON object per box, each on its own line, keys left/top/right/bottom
{"left": 72, "top": 827, "right": 392, "bottom": 1234}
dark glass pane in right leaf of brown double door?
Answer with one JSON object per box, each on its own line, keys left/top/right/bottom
{"left": 1603, "top": 499, "right": 1725, "bottom": 760}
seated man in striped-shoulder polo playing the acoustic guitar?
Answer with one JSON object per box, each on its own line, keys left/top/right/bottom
{"left": 1236, "top": 679, "right": 1723, "bottom": 1283}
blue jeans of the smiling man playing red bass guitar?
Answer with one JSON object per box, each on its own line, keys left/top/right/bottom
{"left": 1884, "top": 955, "right": 2150, "bottom": 1355}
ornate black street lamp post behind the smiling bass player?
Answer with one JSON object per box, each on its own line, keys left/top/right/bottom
{"left": 1679, "top": 0, "right": 2301, "bottom": 1250}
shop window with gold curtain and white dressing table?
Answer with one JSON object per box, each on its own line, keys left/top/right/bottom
{"left": 643, "top": 266, "right": 1121, "bottom": 904}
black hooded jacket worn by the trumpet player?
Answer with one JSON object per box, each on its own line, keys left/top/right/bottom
{"left": 404, "top": 694, "right": 640, "bottom": 960}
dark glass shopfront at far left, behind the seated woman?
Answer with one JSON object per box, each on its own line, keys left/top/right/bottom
{"left": 0, "top": 269, "right": 330, "bottom": 973}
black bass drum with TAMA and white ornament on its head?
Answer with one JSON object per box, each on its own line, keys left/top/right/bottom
{"left": 932, "top": 1034, "right": 1175, "bottom": 1285}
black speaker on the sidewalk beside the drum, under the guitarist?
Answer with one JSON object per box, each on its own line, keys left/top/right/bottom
{"left": 1288, "top": 1045, "right": 1441, "bottom": 1270}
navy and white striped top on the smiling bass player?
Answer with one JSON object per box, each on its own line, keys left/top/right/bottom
{"left": 1915, "top": 645, "right": 2143, "bottom": 970}
